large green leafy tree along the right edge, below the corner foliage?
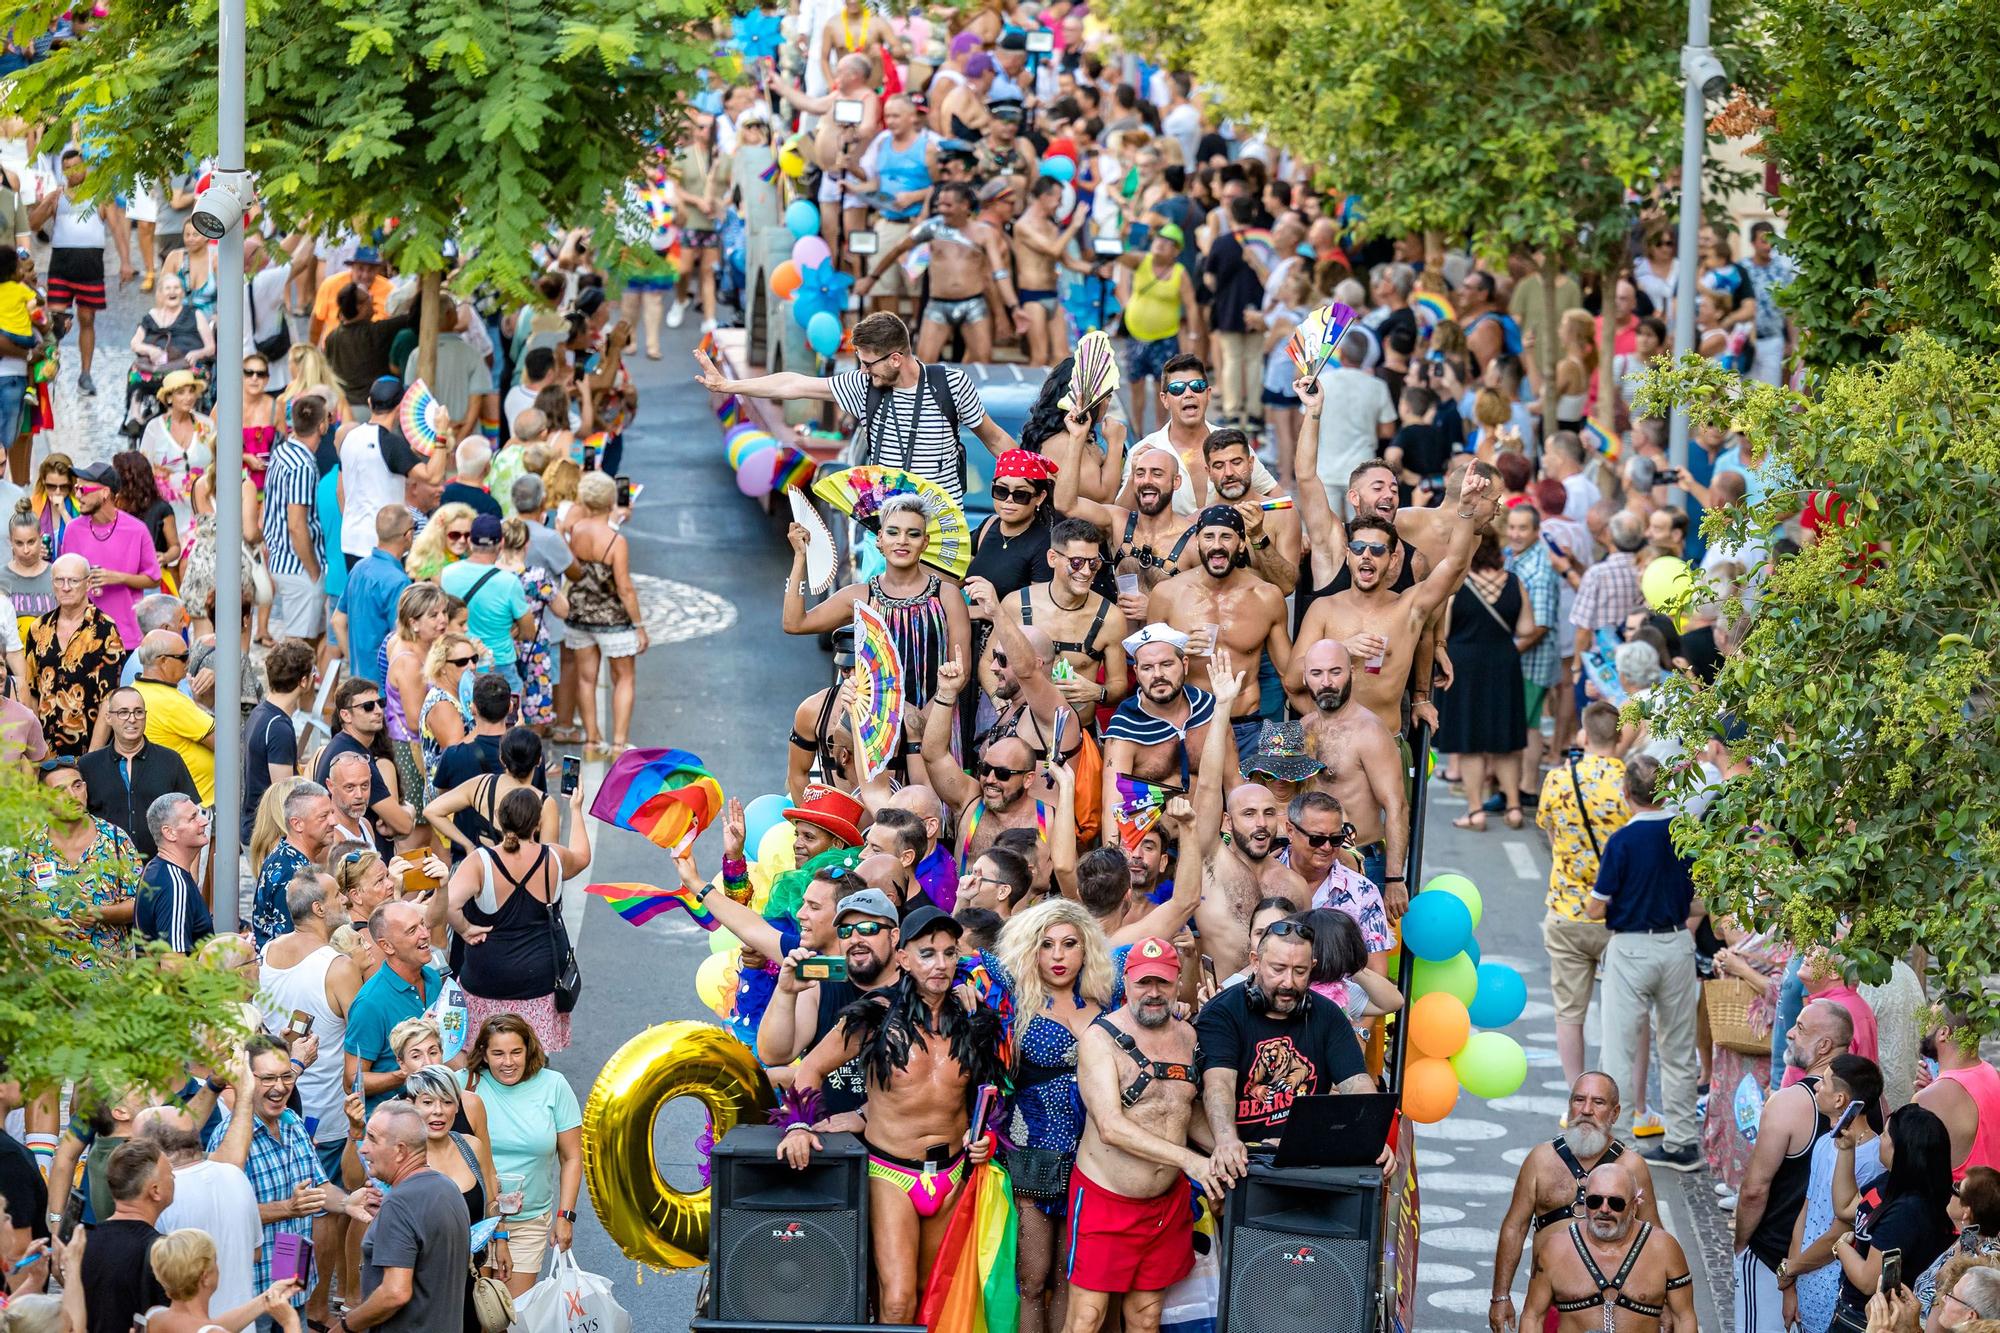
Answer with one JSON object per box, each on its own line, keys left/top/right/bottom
{"left": 1640, "top": 334, "right": 2000, "bottom": 1016}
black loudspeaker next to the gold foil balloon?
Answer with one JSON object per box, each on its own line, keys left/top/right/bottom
{"left": 704, "top": 1125, "right": 868, "bottom": 1329}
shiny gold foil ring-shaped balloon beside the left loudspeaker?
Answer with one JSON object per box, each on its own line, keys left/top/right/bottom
{"left": 584, "top": 1023, "right": 774, "bottom": 1269}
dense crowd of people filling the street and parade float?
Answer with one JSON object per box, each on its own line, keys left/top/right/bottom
{"left": 0, "top": 0, "right": 1976, "bottom": 1333}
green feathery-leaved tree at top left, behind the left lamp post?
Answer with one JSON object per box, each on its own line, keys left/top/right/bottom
{"left": 6, "top": 0, "right": 730, "bottom": 374}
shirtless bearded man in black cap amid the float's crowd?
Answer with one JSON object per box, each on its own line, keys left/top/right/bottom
{"left": 1146, "top": 504, "right": 1292, "bottom": 751}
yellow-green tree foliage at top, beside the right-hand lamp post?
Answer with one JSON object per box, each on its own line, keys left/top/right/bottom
{"left": 1112, "top": 0, "right": 1758, "bottom": 266}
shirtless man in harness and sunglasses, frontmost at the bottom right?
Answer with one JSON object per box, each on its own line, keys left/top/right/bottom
{"left": 1520, "top": 1161, "right": 1694, "bottom": 1333}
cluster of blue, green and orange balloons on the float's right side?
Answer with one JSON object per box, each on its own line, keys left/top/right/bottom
{"left": 1390, "top": 875, "right": 1528, "bottom": 1125}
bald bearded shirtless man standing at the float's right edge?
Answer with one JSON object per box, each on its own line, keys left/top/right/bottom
{"left": 1300, "top": 638, "right": 1410, "bottom": 908}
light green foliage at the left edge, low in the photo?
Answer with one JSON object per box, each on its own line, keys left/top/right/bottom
{"left": 0, "top": 765, "right": 248, "bottom": 1091}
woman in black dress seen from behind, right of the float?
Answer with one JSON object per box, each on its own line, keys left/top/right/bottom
{"left": 1436, "top": 532, "right": 1538, "bottom": 831}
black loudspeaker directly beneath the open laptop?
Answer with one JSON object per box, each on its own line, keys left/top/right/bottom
{"left": 1216, "top": 1161, "right": 1382, "bottom": 1333}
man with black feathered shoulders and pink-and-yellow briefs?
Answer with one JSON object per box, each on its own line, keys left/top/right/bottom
{"left": 778, "top": 909, "right": 1006, "bottom": 1323}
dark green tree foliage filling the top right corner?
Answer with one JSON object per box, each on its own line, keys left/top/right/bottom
{"left": 1764, "top": 0, "right": 2000, "bottom": 366}
